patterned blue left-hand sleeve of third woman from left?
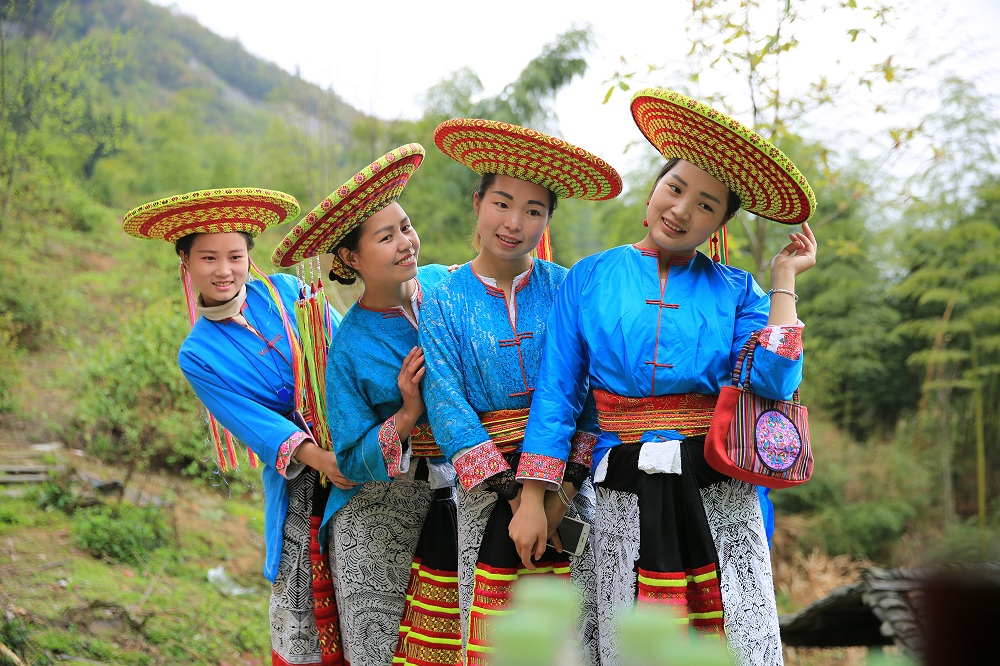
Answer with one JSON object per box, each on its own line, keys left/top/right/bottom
{"left": 420, "top": 290, "right": 490, "bottom": 461}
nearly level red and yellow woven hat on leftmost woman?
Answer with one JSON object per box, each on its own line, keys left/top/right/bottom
{"left": 122, "top": 187, "right": 299, "bottom": 243}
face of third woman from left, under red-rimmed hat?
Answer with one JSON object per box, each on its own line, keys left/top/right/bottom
{"left": 472, "top": 175, "right": 551, "bottom": 261}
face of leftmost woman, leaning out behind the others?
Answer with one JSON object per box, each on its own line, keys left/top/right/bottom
{"left": 181, "top": 232, "right": 250, "bottom": 307}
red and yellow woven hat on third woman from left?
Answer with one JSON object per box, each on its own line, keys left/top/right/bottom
{"left": 434, "top": 118, "right": 622, "bottom": 201}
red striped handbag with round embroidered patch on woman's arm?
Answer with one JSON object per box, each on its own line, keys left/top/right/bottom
{"left": 705, "top": 334, "right": 813, "bottom": 488}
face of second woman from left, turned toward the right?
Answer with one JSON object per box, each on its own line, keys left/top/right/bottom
{"left": 341, "top": 202, "right": 420, "bottom": 288}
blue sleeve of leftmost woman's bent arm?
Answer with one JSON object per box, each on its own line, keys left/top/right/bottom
{"left": 178, "top": 349, "right": 300, "bottom": 468}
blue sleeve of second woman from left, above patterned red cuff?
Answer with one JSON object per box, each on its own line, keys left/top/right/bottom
{"left": 326, "top": 338, "right": 391, "bottom": 483}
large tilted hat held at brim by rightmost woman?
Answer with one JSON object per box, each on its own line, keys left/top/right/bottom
{"left": 632, "top": 88, "right": 816, "bottom": 224}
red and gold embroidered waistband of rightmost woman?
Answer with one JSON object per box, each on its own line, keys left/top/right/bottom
{"left": 594, "top": 389, "right": 719, "bottom": 444}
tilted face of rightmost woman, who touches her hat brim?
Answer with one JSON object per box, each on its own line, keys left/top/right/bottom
{"left": 646, "top": 160, "right": 729, "bottom": 255}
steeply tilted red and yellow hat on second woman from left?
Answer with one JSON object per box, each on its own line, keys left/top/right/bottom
{"left": 271, "top": 143, "right": 424, "bottom": 278}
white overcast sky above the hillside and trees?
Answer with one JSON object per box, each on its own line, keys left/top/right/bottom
{"left": 148, "top": 0, "right": 1000, "bottom": 178}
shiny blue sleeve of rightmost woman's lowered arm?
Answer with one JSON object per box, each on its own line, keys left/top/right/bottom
{"left": 522, "top": 267, "right": 597, "bottom": 460}
